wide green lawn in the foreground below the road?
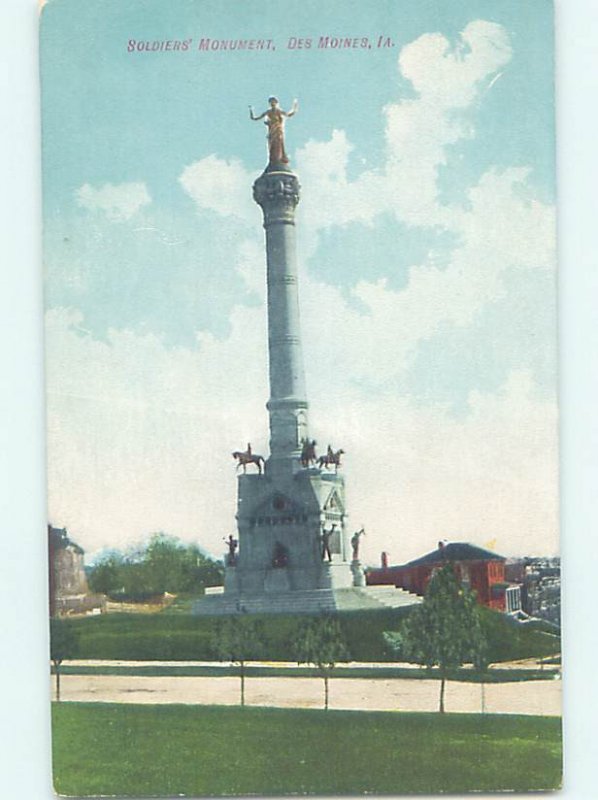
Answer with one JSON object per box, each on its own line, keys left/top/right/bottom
{"left": 53, "top": 703, "right": 561, "bottom": 797}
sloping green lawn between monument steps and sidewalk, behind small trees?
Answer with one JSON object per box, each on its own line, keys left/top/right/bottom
{"left": 63, "top": 608, "right": 560, "bottom": 661}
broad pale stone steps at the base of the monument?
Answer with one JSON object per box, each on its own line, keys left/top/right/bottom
{"left": 193, "top": 586, "right": 421, "bottom": 616}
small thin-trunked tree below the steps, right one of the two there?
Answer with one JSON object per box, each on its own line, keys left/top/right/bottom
{"left": 294, "top": 614, "right": 349, "bottom": 709}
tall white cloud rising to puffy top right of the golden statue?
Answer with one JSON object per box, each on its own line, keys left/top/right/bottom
{"left": 297, "top": 20, "right": 511, "bottom": 230}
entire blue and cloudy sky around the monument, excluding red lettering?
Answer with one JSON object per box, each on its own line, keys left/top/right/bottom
{"left": 41, "top": 0, "right": 558, "bottom": 563}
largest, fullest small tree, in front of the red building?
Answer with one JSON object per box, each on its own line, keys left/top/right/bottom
{"left": 398, "top": 564, "right": 487, "bottom": 713}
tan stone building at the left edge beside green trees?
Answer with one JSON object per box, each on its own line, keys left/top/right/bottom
{"left": 48, "top": 525, "right": 104, "bottom": 617}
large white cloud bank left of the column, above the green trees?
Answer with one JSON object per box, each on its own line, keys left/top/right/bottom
{"left": 47, "top": 308, "right": 267, "bottom": 552}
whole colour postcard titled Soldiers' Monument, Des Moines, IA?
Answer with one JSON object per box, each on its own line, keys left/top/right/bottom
{"left": 40, "top": 0, "right": 562, "bottom": 797}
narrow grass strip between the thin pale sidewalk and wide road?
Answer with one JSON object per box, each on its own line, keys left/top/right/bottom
{"left": 57, "top": 663, "right": 560, "bottom": 683}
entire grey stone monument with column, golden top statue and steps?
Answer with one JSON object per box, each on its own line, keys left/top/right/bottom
{"left": 195, "top": 97, "right": 417, "bottom": 614}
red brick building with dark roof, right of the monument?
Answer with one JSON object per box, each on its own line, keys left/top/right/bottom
{"left": 366, "top": 542, "right": 521, "bottom": 613}
